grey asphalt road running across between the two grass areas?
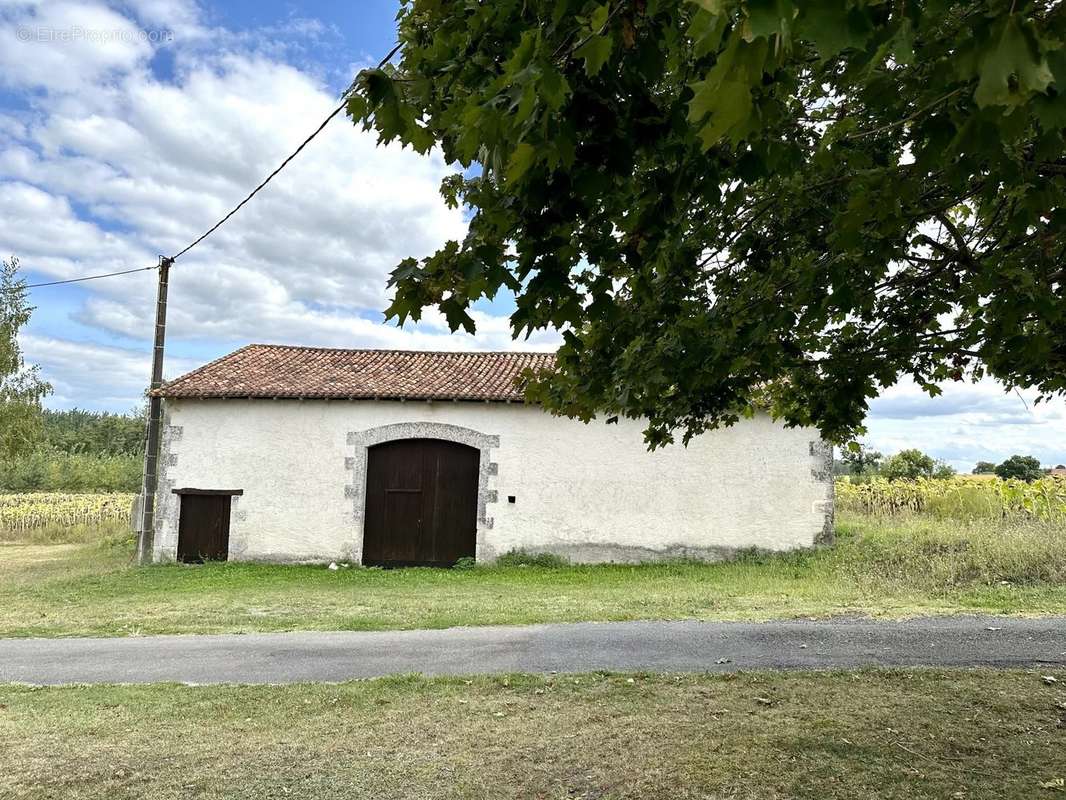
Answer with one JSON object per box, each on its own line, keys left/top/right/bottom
{"left": 0, "top": 617, "right": 1066, "bottom": 685}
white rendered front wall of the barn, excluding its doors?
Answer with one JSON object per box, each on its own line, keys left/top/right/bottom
{"left": 156, "top": 400, "right": 833, "bottom": 561}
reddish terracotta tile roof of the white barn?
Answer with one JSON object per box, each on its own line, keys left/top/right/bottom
{"left": 157, "top": 345, "right": 554, "bottom": 402}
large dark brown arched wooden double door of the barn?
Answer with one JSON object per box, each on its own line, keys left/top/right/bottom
{"left": 362, "top": 438, "right": 480, "bottom": 566}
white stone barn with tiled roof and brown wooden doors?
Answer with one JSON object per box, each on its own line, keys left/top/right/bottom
{"left": 154, "top": 345, "right": 833, "bottom": 565}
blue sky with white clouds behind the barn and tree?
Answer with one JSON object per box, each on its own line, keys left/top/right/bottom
{"left": 0, "top": 0, "right": 1066, "bottom": 468}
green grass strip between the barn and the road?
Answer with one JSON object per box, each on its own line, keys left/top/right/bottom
{"left": 0, "top": 514, "right": 1066, "bottom": 637}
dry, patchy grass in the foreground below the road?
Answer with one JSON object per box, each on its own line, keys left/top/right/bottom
{"left": 0, "top": 670, "right": 1066, "bottom": 800}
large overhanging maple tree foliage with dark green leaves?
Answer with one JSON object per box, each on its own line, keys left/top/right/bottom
{"left": 349, "top": 0, "right": 1066, "bottom": 446}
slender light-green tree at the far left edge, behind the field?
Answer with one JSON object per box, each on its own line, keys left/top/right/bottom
{"left": 0, "top": 257, "right": 51, "bottom": 459}
